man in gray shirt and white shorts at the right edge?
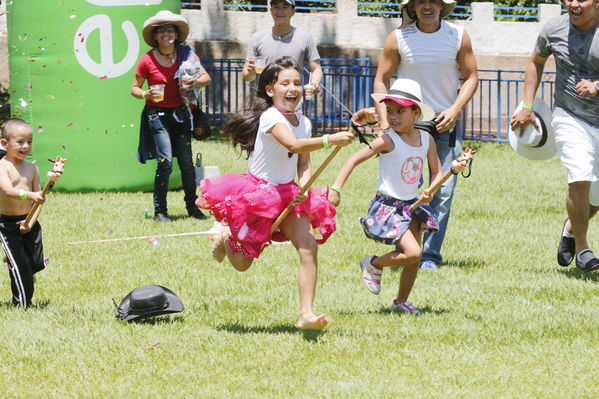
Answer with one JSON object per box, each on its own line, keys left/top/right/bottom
{"left": 511, "top": 0, "right": 599, "bottom": 272}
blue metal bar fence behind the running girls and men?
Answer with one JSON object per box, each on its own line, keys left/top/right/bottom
{"left": 202, "top": 58, "right": 555, "bottom": 142}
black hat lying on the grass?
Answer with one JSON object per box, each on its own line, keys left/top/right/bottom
{"left": 114, "top": 285, "right": 183, "bottom": 321}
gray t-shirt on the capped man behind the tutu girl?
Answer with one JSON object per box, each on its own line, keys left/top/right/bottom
{"left": 247, "top": 28, "right": 320, "bottom": 68}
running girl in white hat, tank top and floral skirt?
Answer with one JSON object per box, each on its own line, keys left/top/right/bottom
{"left": 329, "top": 79, "right": 442, "bottom": 314}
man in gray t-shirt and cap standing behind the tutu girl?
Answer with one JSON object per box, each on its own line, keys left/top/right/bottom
{"left": 243, "top": 0, "right": 322, "bottom": 93}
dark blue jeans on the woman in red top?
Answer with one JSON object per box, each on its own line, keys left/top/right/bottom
{"left": 146, "top": 107, "right": 197, "bottom": 215}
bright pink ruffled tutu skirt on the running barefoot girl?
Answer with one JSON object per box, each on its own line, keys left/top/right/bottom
{"left": 196, "top": 173, "right": 336, "bottom": 258}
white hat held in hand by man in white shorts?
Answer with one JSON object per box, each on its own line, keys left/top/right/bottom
{"left": 508, "top": 98, "right": 557, "bottom": 161}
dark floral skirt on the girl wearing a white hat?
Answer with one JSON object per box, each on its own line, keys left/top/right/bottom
{"left": 360, "top": 193, "right": 439, "bottom": 245}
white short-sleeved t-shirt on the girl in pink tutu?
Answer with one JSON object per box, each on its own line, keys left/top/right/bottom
{"left": 248, "top": 107, "right": 312, "bottom": 184}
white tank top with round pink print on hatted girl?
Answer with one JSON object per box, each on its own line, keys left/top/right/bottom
{"left": 377, "top": 130, "right": 430, "bottom": 201}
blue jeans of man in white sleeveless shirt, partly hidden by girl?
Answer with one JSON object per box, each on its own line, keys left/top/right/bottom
{"left": 422, "top": 120, "right": 463, "bottom": 263}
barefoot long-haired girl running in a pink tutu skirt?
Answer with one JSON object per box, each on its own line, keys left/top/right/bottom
{"left": 196, "top": 57, "right": 353, "bottom": 330}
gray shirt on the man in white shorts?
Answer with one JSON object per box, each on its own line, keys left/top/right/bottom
{"left": 535, "top": 14, "right": 599, "bottom": 127}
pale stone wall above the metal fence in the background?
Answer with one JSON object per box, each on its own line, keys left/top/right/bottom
{"left": 183, "top": 0, "right": 561, "bottom": 69}
